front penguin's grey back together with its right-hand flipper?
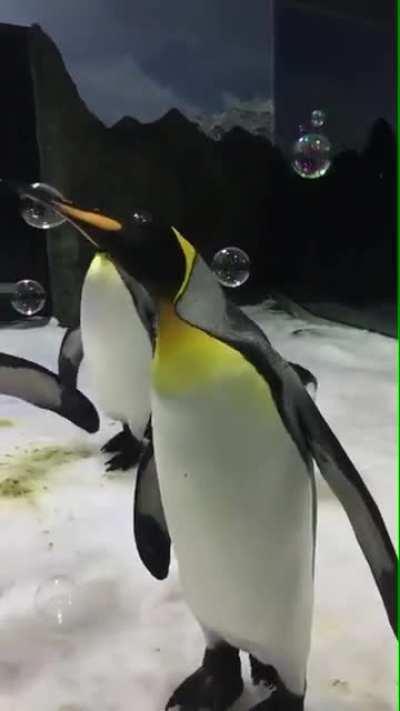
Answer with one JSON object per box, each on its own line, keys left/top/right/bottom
{"left": 175, "top": 256, "right": 397, "bottom": 635}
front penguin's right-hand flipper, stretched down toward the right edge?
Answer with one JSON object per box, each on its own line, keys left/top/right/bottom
{"left": 297, "top": 392, "right": 397, "bottom": 636}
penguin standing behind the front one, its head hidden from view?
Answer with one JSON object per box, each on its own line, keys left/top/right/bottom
{"left": 58, "top": 222, "right": 153, "bottom": 470}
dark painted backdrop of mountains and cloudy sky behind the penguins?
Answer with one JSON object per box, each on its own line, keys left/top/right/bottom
{"left": 0, "top": 0, "right": 396, "bottom": 332}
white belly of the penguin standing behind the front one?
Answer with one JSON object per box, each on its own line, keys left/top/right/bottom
{"left": 81, "top": 256, "right": 152, "bottom": 435}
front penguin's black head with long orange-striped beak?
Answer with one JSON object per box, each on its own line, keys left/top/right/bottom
{"left": 9, "top": 183, "right": 187, "bottom": 302}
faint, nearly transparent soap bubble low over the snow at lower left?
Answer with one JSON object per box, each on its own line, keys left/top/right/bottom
{"left": 35, "top": 575, "right": 75, "bottom": 630}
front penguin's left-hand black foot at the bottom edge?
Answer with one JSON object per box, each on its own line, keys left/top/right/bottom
{"left": 166, "top": 643, "right": 243, "bottom": 711}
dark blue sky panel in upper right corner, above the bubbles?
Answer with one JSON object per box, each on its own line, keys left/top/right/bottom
{"left": 275, "top": 0, "right": 395, "bottom": 153}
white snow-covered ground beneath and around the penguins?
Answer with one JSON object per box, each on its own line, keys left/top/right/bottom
{"left": 0, "top": 307, "right": 395, "bottom": 711}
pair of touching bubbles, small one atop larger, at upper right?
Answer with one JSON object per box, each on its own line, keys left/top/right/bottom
{"left": 292, "top": 109, "right": 332, "bottom": 180}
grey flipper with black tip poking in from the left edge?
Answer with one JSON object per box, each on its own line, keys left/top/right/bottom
{"left": 0, "top": 353, "right": 99, "bottom": 432}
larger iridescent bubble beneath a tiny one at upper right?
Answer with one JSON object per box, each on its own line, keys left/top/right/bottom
{"left": 292, "top": 133, "right": 331, "bottom": 179}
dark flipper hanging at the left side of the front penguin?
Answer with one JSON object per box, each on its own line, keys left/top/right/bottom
{"left": 133, "top": 432, "right": 171, "bottom": 580}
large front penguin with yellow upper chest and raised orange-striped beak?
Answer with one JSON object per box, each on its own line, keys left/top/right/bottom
{"left": 6, "top": 181, "right": 397, "bottom": 711}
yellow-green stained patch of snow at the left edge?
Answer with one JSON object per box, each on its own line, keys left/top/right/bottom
{"left": 0, "top": 446, "right": 92, "bottom": 499}
